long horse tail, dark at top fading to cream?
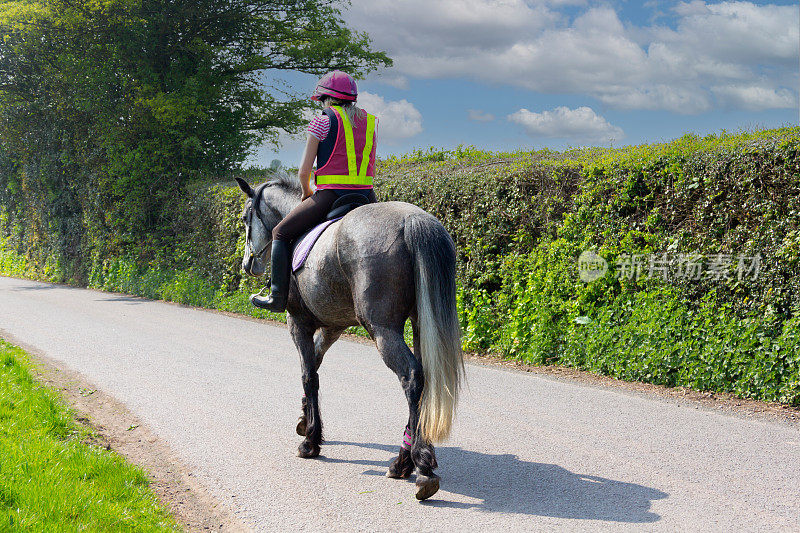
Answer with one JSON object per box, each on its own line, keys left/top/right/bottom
{"left": 405, "top": 213, "right": 464, "bottom": 442}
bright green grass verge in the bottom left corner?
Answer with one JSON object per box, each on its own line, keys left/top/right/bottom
{"left": 0, "top": 340, "right": 179, "bottom": 531}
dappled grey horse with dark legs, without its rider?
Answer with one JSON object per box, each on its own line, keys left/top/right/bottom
{"left": 236, "top": 171, "right": 464, "bottom": 500}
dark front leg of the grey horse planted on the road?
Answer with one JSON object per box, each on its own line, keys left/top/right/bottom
{"left": 287, "top": 315, "right": 322, "bottom": 458}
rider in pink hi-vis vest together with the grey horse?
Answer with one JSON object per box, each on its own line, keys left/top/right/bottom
{"left": 236, "top": 72, "right": 464, "bottom": 500}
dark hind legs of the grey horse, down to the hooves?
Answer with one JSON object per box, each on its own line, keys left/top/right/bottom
{"left": 373, "top": 327, "right": 439, "bottom": 500}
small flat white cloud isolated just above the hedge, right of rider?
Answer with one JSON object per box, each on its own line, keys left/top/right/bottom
{"left": 508, "top": 107, "right": 625, "bottom": 143}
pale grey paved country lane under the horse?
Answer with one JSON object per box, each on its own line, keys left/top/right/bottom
{"left": 0, "top": 277, "right": 800, "bottom": 532}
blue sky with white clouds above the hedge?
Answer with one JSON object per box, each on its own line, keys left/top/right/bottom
{"left": 249, "top": 0, "right": 800, "bottom": 166}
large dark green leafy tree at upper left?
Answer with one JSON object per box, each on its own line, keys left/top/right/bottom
{"left": 0, "top": 0, "right": 391, "bottom": 280}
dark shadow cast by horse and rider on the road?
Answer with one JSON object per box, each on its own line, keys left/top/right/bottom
{"left": 320, "top": 441, "right": 668, "bottom": 523}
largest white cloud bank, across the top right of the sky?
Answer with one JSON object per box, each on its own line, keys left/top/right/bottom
{"left": 346, "top": 0, "right": 800, "bottom": 113}
